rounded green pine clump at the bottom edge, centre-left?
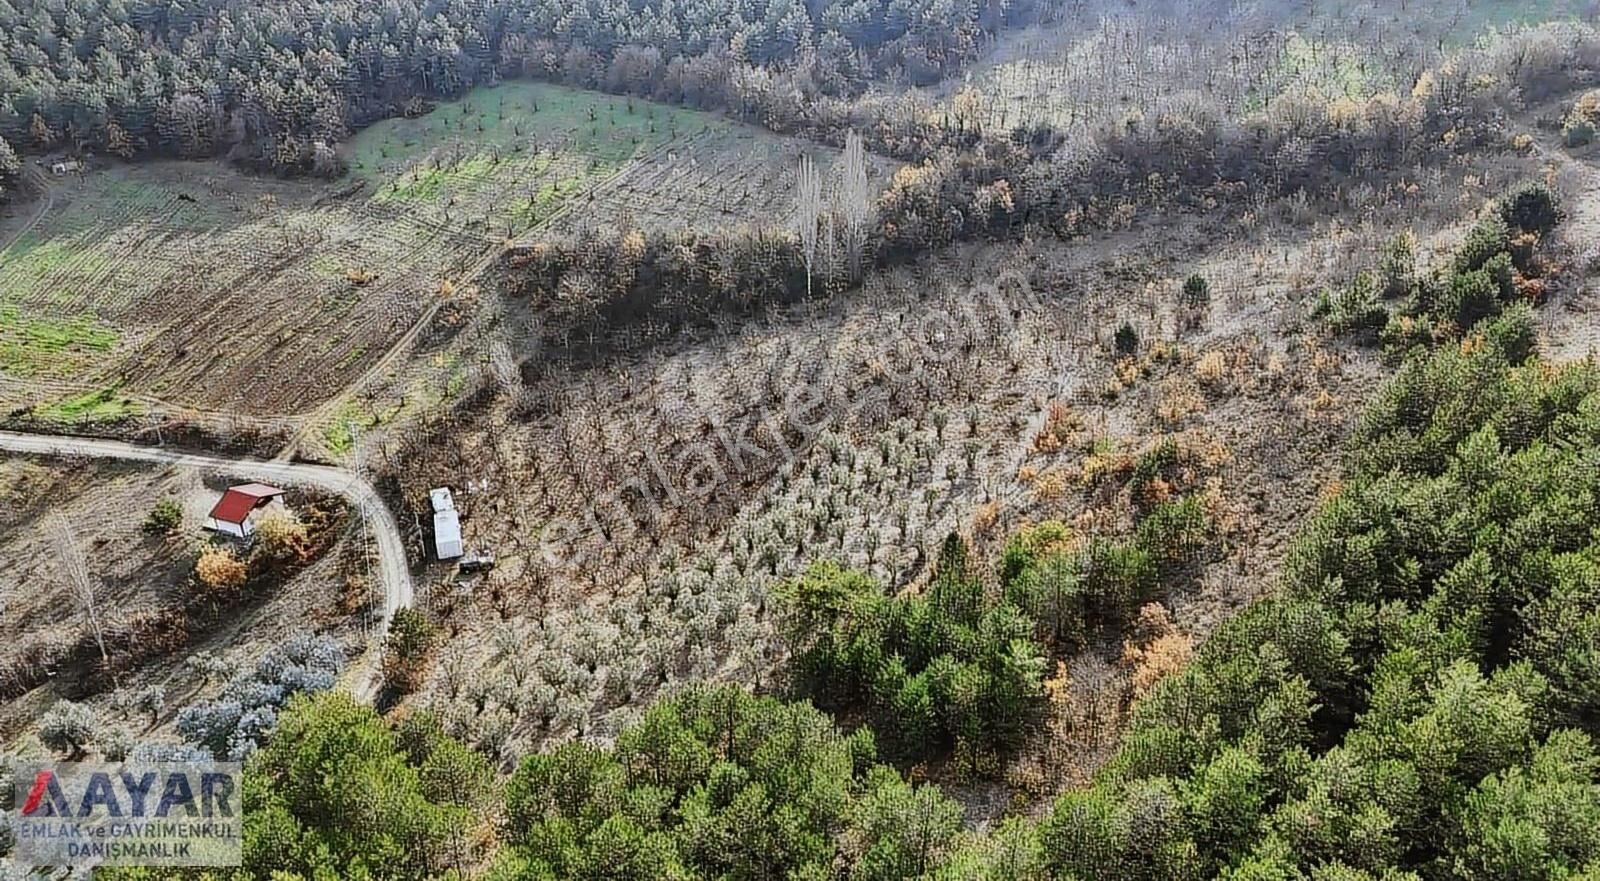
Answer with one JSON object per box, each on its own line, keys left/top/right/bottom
{"left": 490, "top": 686, "right": 962, "bottom": 881}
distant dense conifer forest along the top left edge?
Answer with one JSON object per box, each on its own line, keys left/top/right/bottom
{"left": 0, "top": 0, "right": 1040, "bottom": 174}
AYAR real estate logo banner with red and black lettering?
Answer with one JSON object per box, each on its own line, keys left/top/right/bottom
{"left": 6, "top": 761, "right": 243, "bottom": 867}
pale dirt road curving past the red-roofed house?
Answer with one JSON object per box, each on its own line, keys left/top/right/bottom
{"left": 0, "top": 432, "right": 413, "bottom": 700}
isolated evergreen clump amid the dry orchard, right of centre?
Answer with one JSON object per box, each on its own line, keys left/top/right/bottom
{"left": 779, "top": 479, "right": 1208, "bottom": 774}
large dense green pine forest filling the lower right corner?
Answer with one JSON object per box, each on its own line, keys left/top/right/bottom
{"left": 1040, "top": 313, "right": 1600, "bottom": 879}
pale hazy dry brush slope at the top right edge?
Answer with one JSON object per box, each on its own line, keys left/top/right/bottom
{"left": 934, "top": 0, "right": 1589, "bottom": 133}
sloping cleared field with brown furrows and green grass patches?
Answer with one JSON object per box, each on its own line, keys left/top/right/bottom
{"left": 0, "top": 83, "right": 851, "bottom": 422}
